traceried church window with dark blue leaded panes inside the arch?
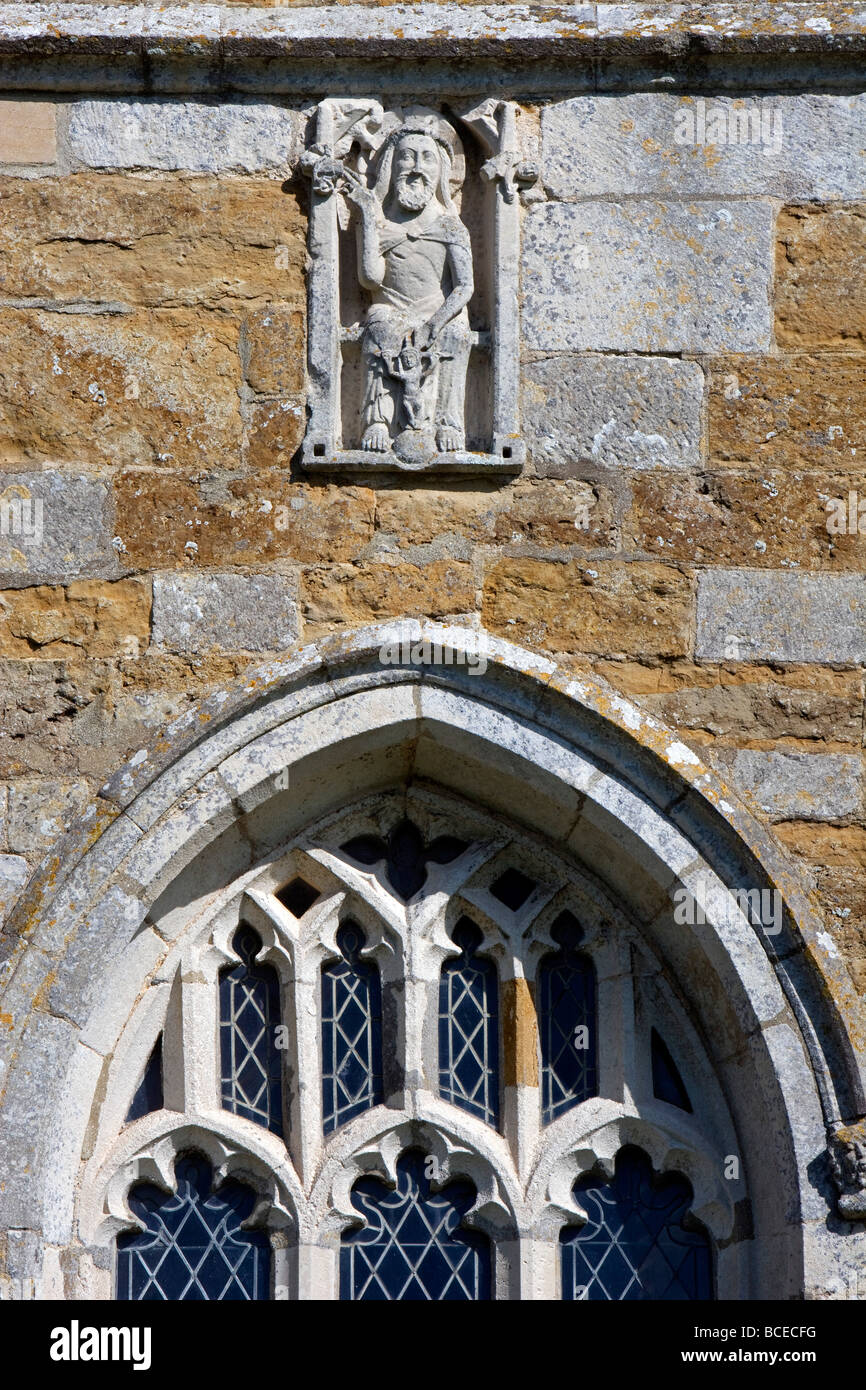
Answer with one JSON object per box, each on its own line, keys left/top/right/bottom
{"left": 100, "top": 798, "right": 737, "bottom": 1301}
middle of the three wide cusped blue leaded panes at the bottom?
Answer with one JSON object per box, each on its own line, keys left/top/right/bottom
{"left": 339, "top": 1150, "right": 491, "bottom": 1302}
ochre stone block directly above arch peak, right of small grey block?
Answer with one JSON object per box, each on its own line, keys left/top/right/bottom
{"left": 302, "top": 560, "right": 475, "bottom": 637}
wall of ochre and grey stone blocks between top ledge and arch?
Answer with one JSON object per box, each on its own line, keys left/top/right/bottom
{"left": 0, "top": 16, "right": 866, "bottom": 1017}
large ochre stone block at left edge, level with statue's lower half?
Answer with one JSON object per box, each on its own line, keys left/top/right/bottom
{"left": 0, "top": 309, "right": 242, "bottom": 472}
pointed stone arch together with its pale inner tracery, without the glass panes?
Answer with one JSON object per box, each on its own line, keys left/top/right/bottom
{"left": 0, "top": 623, "right": 866, "bottom": 1298}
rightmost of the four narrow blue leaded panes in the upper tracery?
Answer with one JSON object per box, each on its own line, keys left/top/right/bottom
{"left": 538, "top": 912, "right": 598, "bottom": 1125}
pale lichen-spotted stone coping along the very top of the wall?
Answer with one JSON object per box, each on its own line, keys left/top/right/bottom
{"left": 0, "top": 0, "right": 866, "bottom": 63}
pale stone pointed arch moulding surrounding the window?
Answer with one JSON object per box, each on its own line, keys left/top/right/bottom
{"left": 0, "top": 621, "right": 866, "bottom": 1298}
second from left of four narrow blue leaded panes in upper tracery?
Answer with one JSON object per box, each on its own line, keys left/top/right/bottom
{"left": 321, "top": 922, "right": 384, "bottom": 1134}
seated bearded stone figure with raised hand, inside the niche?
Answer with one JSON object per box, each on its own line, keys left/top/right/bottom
{"left": 343, "top": 114, "right": 474, "bottom": 457}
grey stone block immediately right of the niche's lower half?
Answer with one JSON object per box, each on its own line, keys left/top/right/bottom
{"left": 523, "top": 353, "right": 703, "bottom": 478}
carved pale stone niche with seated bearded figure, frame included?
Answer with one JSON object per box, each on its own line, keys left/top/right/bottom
{"left": 302, "top": 99, "right": 538, "bottom": 474}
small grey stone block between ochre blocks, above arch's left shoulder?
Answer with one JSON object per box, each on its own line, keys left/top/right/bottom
{"left": 153, "top": 574, "right": 297, "bottom": 652}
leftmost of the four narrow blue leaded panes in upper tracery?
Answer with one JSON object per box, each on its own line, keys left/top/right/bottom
{"left": 220, "top": 926, "right": 282, "bottom": 1134}
